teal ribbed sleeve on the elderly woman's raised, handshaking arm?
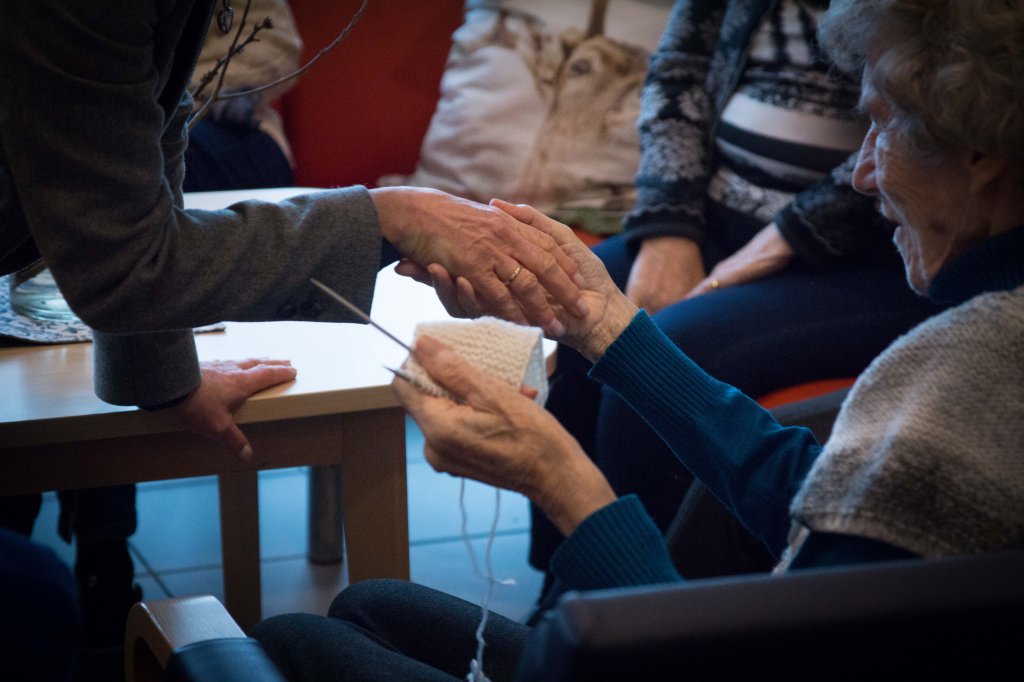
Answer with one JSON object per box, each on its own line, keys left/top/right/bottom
{"left": 590, "top": 310, "right": 821, "bottom": 556}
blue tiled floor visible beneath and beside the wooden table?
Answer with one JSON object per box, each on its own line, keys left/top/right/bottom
{"left": 24, "top": 411, "right": 541, "bottom": 620}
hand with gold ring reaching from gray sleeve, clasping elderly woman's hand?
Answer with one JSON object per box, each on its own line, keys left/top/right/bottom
{"left": 371, "top": 187, "right": 586, "bottom": 335}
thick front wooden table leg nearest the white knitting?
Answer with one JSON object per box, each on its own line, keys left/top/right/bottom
{"left": 341, "top": 408, "right": 409, "bottom": 584}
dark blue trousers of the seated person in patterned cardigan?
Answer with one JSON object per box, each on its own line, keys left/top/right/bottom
{"left": 529, "top": 228, "right": 938, "bottom": 579}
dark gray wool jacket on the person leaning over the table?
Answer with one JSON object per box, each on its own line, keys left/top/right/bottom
{"left": 0, "top": 0, "right": 381, "bottom": 404}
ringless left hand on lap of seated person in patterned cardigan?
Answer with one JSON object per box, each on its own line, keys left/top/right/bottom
{"left": 626, "top": 237, "right": 705, "bottom": 314}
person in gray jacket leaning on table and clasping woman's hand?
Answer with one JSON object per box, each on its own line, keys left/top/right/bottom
{"left": 0, "top": 0, "right": 580, "bottom": 455}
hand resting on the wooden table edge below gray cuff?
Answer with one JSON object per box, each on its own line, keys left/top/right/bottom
{"left": 166, "top": 358, "right": 296, "bottom": 460}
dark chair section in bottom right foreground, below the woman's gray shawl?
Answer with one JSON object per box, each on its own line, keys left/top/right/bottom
{"left": 516, "top": 551, "right": 1024, "bottom": 682}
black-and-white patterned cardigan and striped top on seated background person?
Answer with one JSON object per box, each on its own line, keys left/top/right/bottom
{"left": 625, "top": 0, "right": 901, "bottom": 268}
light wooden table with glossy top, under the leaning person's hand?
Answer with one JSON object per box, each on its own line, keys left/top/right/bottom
{"left": 0, "top": 189, "right": 447, "bottom": 628}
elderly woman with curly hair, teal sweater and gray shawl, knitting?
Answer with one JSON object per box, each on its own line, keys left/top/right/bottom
{"left": 256, "top": 0, "right": 1024, "bottom": 680}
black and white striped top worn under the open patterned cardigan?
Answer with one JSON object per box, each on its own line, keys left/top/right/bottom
{"left": 708, "top": 0, "right": 867, "bottom": 224}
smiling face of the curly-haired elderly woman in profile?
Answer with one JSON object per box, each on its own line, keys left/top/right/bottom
{"left": 853, "top": 65, "right": 976, "bottom": 294}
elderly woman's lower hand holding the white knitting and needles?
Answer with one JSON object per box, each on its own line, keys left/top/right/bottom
{"left": 391, "top": 337, "right": 615, "bottom": 535}
